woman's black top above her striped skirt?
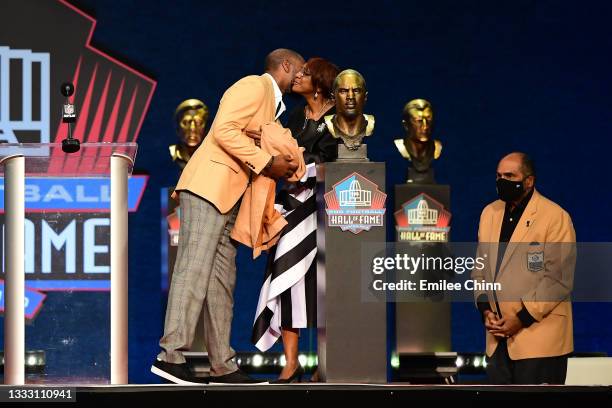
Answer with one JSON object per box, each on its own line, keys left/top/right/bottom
{"left": 287, "top": 104, "right": 341, "bottom": 163}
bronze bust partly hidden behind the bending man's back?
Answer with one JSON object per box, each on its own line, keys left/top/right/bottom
{"left": 168, "top": 99, "right": 208, "bottom": 170}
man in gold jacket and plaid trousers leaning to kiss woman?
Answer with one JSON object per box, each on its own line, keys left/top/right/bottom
{"left": 151, "top": 49, "right": 304, "bottom": 384}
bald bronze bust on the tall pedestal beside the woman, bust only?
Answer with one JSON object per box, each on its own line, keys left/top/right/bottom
{"left": 325, "top": 69, "right": 375, "bottom": 160}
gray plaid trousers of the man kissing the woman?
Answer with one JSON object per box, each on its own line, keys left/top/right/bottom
{"left": 158, "top": 191, "right": 240, "bottom": 375}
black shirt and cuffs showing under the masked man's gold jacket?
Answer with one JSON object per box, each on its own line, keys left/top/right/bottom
{"left": 477, "top": 190, "right": 535, "bottom": 327}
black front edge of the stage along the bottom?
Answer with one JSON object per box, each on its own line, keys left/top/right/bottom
{"left": 0, "top": 384, "right": 612, "bottom": 407}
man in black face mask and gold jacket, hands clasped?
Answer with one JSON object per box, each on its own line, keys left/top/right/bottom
{"left": 472, "top": 152, "right": 576, "bottom": 384}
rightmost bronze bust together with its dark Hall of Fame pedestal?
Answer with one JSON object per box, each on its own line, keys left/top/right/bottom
{"left": 394, "top": 99, "right": 451, "bottom": 369}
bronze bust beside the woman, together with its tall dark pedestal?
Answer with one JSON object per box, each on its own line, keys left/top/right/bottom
{"left": 317, "top": 69, "right": 387, "bottom": 383}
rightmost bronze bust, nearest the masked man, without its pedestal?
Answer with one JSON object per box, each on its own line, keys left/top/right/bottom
{"left": 394, "top": 99, "right": 442, "bottom": 184}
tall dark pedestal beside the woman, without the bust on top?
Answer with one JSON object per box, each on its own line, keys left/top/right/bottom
{"left": 317, "top": 161, "right": 387, "bottom": 383}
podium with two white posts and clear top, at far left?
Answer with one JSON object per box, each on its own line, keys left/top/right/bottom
{"left": 0, "top": 143, "right": 138, "bottom": 385}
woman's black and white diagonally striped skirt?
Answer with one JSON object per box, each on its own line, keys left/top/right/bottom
{"left": 251, "top": 163, "right": 317, "bottom": 351}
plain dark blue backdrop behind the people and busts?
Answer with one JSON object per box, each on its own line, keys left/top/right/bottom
{"left": 75, "top": 0, "right": 612, "bottom": 382}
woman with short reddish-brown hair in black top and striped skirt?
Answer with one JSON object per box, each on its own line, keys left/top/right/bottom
{"left": 252, "top": 58, "right": 339, "bottom": 382}
